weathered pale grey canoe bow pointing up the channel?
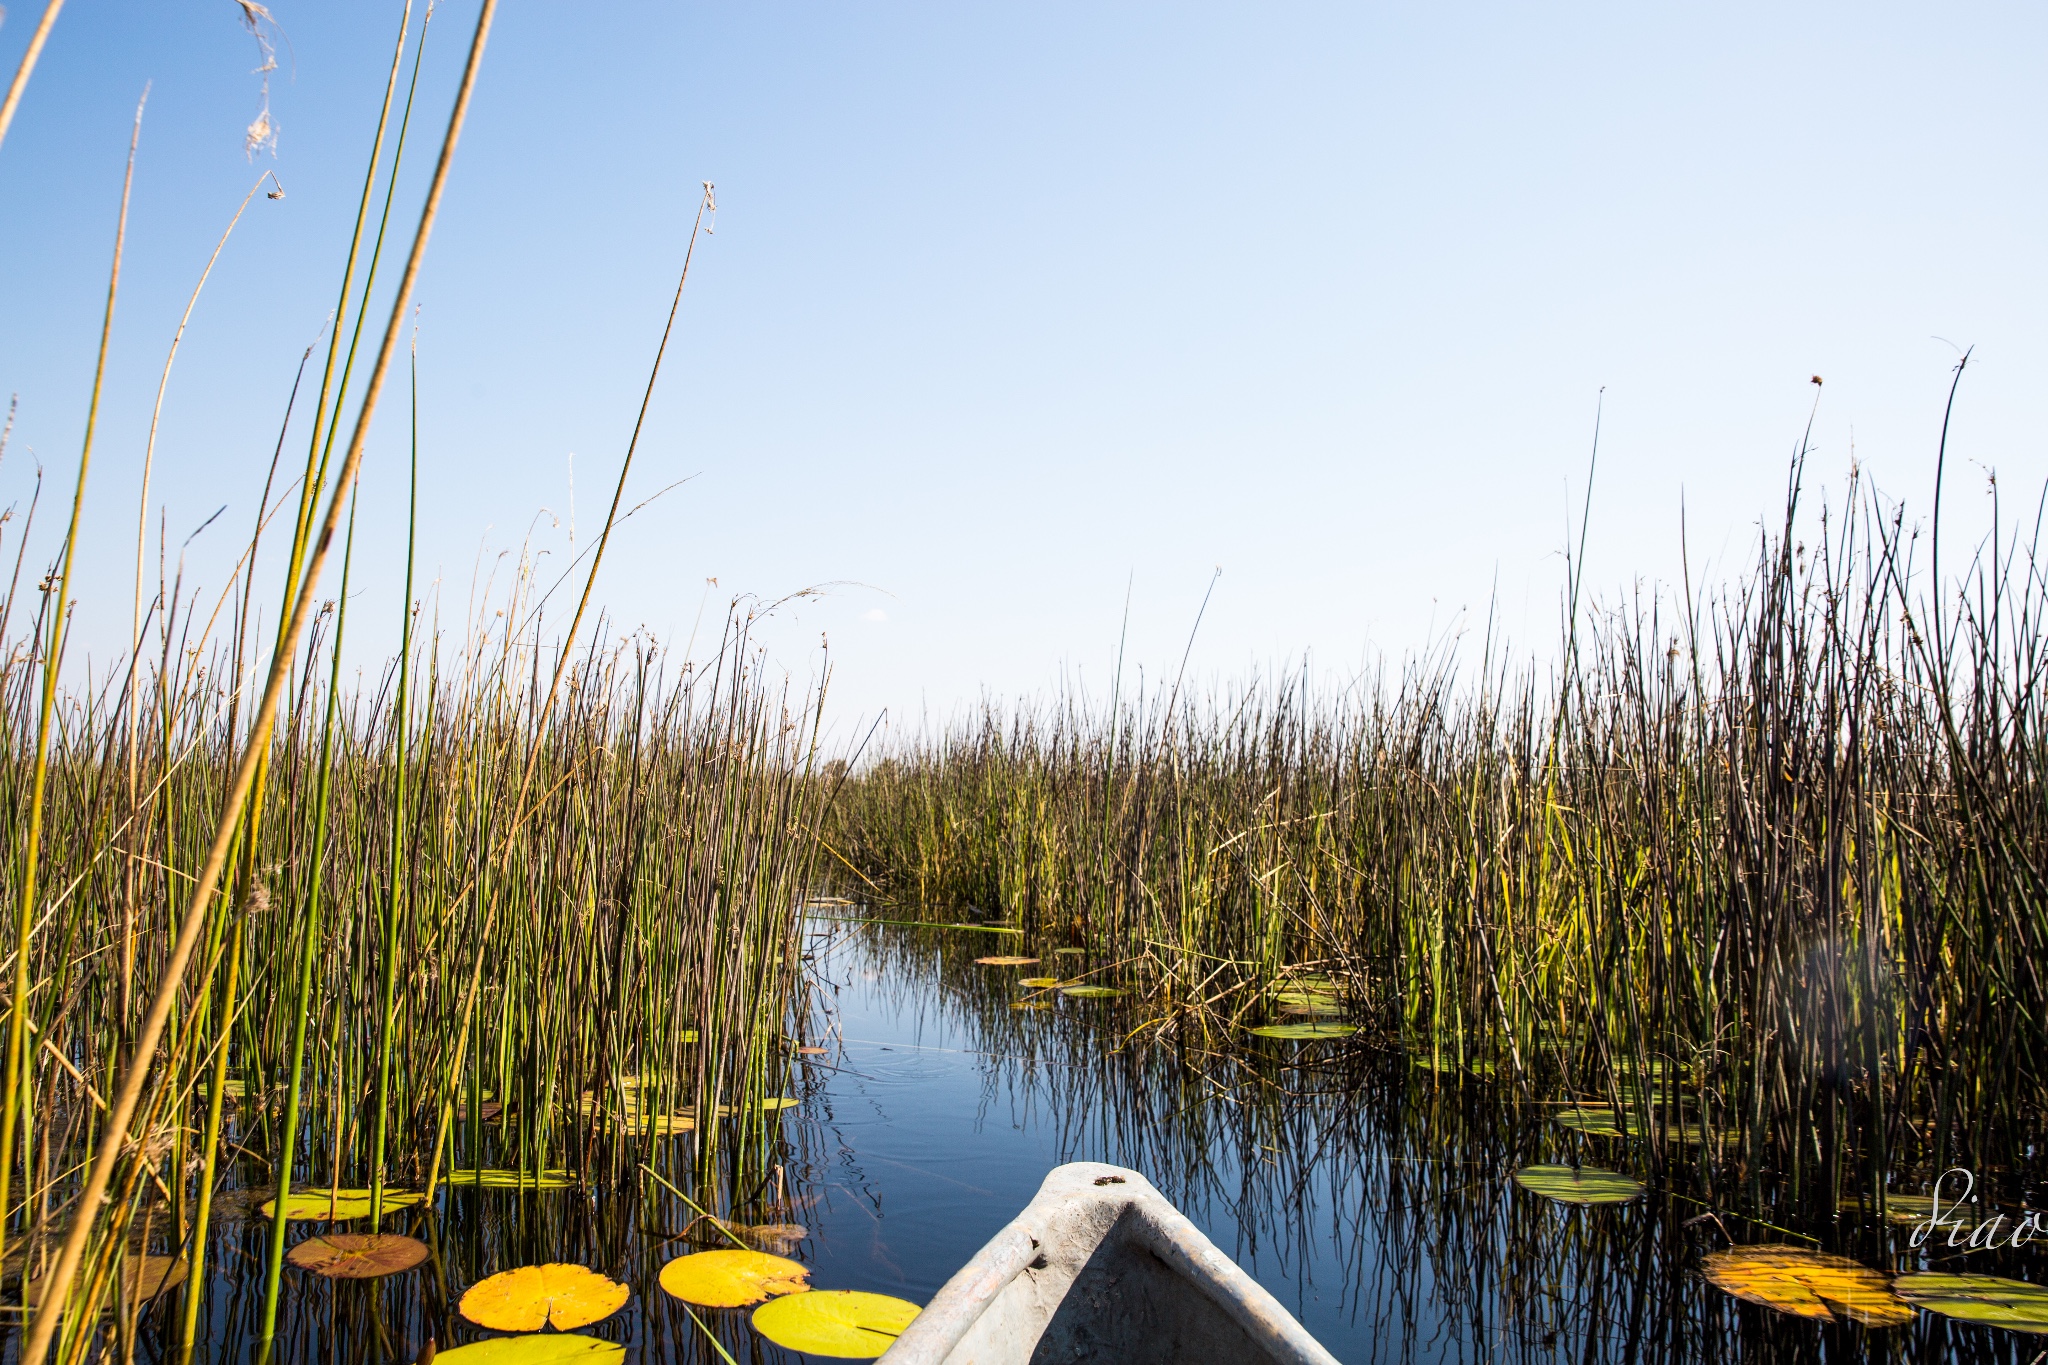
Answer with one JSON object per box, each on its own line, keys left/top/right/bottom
{"left": 881, "top": 1160, "right": 1337, "bottom": 1365}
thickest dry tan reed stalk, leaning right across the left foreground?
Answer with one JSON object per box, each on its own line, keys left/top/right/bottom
{"left": 20, "top": 0, "right": 498, "bottom": 1365}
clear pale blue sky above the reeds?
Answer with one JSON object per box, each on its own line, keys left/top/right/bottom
{"left": 0, "top": 0, "right": 2048, "bottom": 733}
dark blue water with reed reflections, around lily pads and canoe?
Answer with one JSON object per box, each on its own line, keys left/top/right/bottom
{"left": 39, "top": 921, "right": 2042, "bottom": 1365}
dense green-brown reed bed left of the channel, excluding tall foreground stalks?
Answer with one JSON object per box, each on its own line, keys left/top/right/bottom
{"left": 0, "top": 568, "right": 817, "bottom": 1349}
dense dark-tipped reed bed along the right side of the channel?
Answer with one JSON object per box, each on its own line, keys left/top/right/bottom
{"left": 829, "top": 467, "right": 2048, "bottom": 1212}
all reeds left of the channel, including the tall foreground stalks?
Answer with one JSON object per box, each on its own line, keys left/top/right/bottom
{"left": 0, "top": 0, "right": 819, "bottom": 1361}
